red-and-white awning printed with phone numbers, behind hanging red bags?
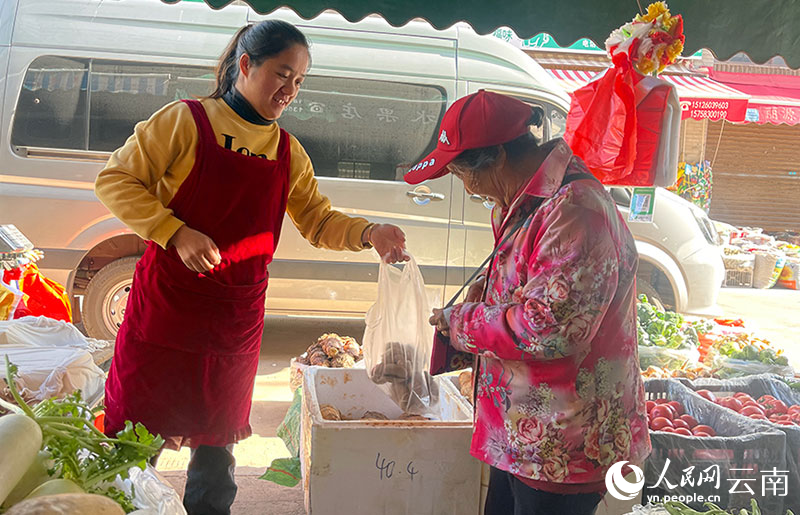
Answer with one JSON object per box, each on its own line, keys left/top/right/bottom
{"left": 547, "top": 70, "right": 748, "bottom": 122}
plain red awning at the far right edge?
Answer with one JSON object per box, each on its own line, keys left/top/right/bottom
{"left": 710, "top": 70, "right": 800, "bottom": 125}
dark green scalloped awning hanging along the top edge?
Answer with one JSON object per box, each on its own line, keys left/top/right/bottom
{"left": 173, "top": 0, "right": 800, "bottom": 68}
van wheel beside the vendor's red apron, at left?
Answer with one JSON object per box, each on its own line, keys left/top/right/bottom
{"left": 81, "top": 256, "right": 139, "bottom": 340}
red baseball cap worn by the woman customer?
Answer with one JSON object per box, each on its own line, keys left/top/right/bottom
{"left": 404, "top": 89, "right": 532, "bottom": 184}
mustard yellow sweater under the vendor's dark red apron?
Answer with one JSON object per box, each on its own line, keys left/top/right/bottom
{"left": 95, "top": 99, "right": 368, "bottom": 250}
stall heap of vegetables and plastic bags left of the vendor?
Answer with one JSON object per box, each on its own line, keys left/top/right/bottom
{"left": 0, "top": 225, "right": 185, "bottom": 515}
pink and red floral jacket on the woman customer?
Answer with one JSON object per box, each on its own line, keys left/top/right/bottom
{"left": 446, "top": 140, "right": 650, "bottom": 484}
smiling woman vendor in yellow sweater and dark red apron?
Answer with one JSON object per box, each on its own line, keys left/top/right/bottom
{"left": 95, "top": 20, "right": 405, "bottom": 515}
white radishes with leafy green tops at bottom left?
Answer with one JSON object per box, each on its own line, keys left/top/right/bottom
{"left": 0, "top": 358, "right": 164, "bottom": 512}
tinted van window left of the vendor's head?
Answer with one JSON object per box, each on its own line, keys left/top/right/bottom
{"left": 11, "top": 56, "right": 214, "bottom": 151}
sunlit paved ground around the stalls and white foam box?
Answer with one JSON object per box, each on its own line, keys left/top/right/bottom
{"left": 153, "top": 289, "right": 800, "bottom": 515}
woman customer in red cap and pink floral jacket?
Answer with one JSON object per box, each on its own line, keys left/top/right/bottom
{"left": 405, "top": 91, "right": 650, "bottom": 515}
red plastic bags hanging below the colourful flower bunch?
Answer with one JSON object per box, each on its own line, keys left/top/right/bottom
{"left": 564, "top": 56, "right": 681, "bottom": 186}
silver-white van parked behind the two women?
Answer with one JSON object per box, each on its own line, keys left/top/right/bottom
{"left": 0, "top": 0, "right": 723, "bottom": 338}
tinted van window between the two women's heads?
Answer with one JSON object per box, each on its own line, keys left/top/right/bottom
{"left": 280, "top": 76, "right": 447, "bottom": 181}
